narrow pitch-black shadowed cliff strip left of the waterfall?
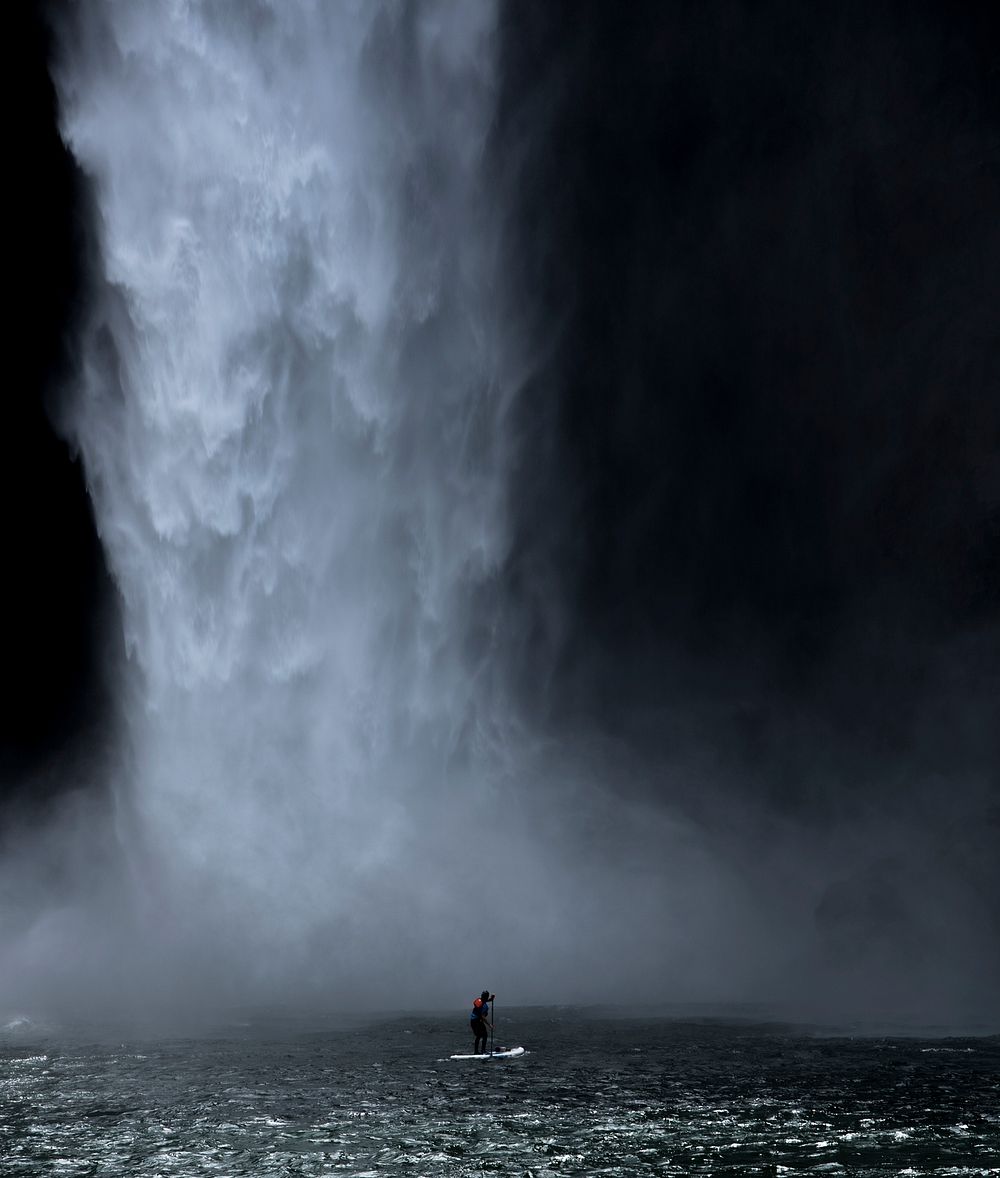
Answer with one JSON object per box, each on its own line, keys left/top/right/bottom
{"left": 0, "top": 5, "right": 118, "bottom": 800}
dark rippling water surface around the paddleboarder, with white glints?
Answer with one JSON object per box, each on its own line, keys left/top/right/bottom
{"left": 0, "top": 1012, "right": 1000, "bottom": 1176}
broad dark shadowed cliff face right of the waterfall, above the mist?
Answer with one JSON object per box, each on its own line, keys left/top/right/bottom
{"left": 497, "top": 4, "right": 1000, "bottom": 812}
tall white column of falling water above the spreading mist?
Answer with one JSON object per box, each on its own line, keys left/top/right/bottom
{"left": 49, "top": 0, "right": 530, "bottom": 1003}
